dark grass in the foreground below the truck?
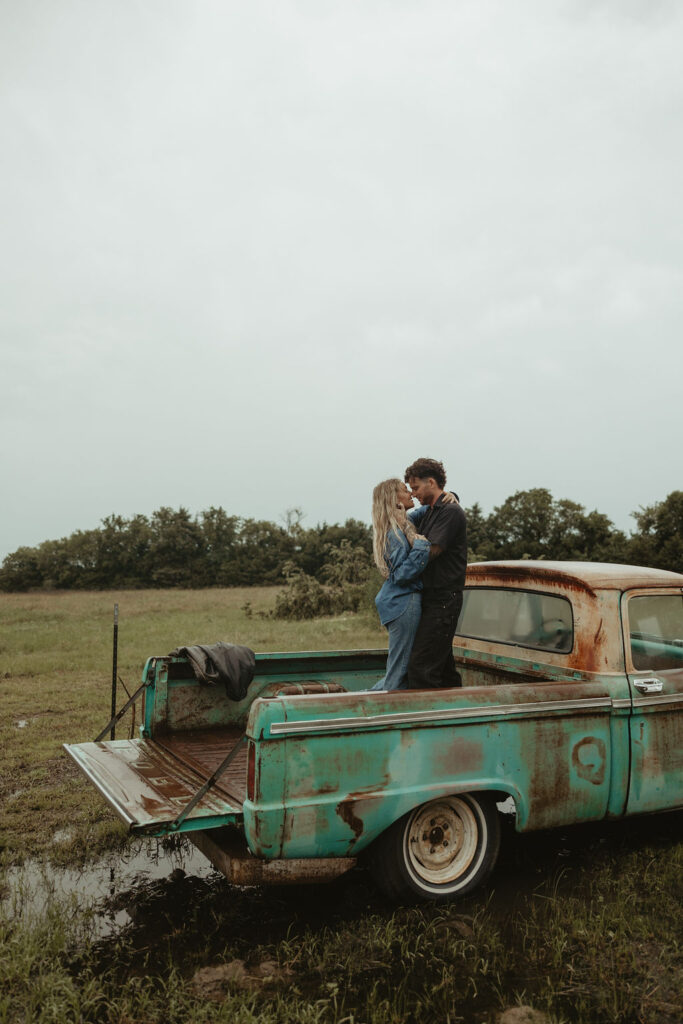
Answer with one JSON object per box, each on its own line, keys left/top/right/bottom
{"left": 0, "top": 815, "right": 683, "bottom": 1024}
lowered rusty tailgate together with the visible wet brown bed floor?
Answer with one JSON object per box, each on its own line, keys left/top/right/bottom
{"left": 65, "top": 730, "right": 247, "bottom": 836}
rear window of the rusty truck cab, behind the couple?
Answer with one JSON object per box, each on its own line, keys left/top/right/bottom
{"left": 457, "top": 587, "right": 573, "bottom": 654}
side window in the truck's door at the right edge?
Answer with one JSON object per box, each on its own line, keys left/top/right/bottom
{"left": 629, "top": 594, "right": 683, "bottom": 672}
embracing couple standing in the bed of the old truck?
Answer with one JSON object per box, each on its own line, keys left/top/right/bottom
{"left": 373, "top": 459, "right": 467, "bottom": 690}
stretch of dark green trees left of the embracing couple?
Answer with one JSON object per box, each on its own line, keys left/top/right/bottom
{"left": 0, "top": 508, "right": 372, "bottom": 591}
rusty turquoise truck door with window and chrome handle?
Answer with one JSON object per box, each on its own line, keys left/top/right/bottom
{"left": 622, "top": 588, "right": 683, "bottom": 814}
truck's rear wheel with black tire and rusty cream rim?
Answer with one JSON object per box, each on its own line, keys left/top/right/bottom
{"left": 371, "top": 793, "right": 501, "bottom": 903}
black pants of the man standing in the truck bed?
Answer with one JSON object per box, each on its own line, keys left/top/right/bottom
{"left": 407, "top": 592, "right": 463, "bottom": 690}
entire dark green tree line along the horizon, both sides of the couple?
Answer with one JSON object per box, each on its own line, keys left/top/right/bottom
{"left": 0, "top": 487, "right": 683, "bottom": 592}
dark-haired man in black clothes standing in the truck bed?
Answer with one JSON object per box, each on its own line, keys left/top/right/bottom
{"left": 404, "top": 459, "right": 467, "bottom": 689}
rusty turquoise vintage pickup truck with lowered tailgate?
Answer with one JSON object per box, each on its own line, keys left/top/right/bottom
{"left": 66, "top": 561, "right": 683, "bottom": 900}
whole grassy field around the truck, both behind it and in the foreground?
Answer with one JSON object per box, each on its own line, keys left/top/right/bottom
{"left": 0, "top": 589, "right": 683, "bottom": 1024}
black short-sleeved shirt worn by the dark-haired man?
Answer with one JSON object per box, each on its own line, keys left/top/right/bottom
{"left": 418, "top": 495, "right": 467, "bottom": 600}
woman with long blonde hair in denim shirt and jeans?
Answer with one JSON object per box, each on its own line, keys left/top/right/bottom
{"left": 372, "top": 479, "right": 429, "bottom": 690}
